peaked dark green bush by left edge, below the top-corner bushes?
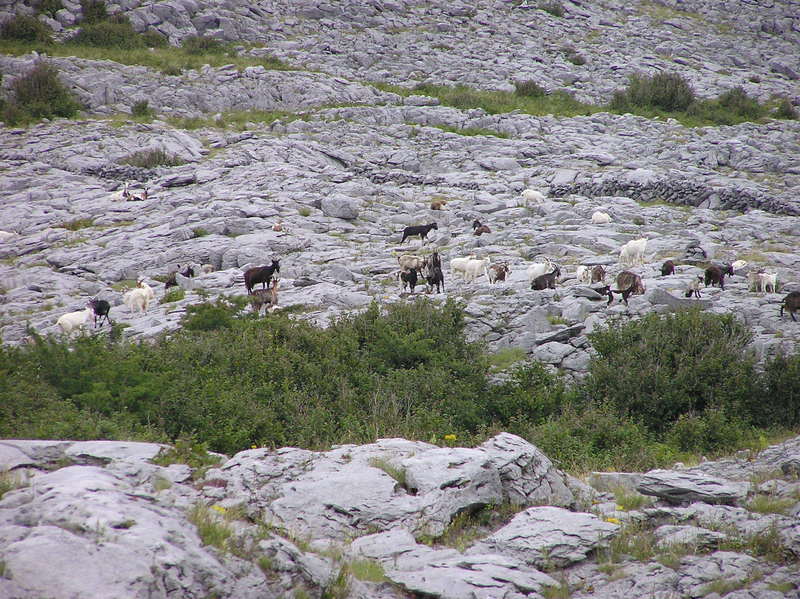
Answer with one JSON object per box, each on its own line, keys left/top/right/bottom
{"left": 4, "top": 61, "right": 80, "bottom": 123}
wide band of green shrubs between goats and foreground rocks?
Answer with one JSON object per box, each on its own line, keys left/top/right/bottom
{"left": 0, "top": 297, "right": 800, "bottom": 474}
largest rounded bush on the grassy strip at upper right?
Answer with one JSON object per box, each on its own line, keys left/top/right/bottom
{"left": 611, "top": 73, "right": 694, "bottom": 111}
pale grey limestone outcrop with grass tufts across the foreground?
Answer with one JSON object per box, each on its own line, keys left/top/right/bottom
{"left": 0, "top": 433, "right": 800, "bottom": 599}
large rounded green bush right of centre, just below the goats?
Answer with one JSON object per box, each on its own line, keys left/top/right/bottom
{"left": 584, "top": 311, "right": 758, "bottom": 432}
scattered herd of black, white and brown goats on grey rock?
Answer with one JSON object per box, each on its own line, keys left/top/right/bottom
{"left": 48, "top": 191, "right": 800, "bottom": 334}
